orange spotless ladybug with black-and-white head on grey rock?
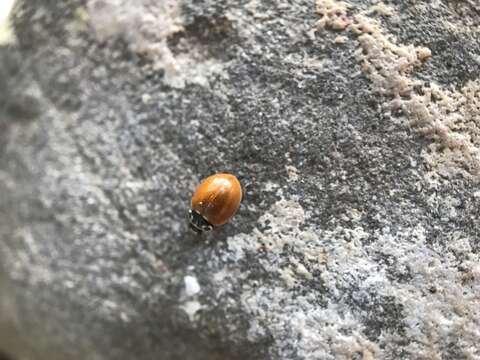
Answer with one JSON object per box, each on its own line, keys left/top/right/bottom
{"left": 189, "top": 173, "right": 242, "bottom": 234}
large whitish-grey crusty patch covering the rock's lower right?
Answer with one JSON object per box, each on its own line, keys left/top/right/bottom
{"left": 219, "top": 199, "right": 480, "bottom": 360}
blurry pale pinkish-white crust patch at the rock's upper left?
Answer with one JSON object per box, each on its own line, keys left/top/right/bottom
{"left": 87, "top": 0, "right": 222, "bottom": 88}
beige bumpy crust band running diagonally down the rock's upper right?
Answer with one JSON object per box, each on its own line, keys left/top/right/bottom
{"left": 317, "top": 0, "right": 480, "bottom": 179}
